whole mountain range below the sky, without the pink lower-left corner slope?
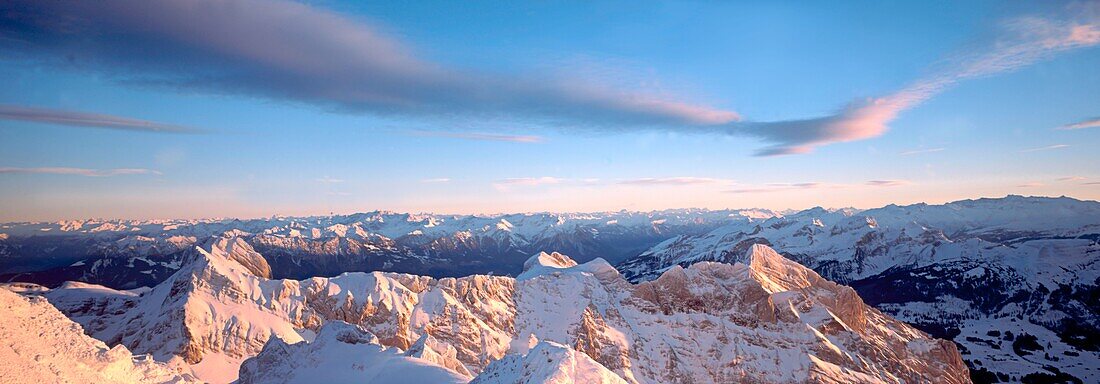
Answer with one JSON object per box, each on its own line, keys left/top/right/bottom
{"left": 0, "top": 196, "right": 1100, "bottom": 383}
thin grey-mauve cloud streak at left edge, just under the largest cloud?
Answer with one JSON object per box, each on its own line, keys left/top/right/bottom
{"left": 0, "top": 105, "right": 201, "bottom": 133}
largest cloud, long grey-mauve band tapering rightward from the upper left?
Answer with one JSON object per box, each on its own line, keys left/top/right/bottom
{"left": 0, "top": 0, "right": 739, "bottom": 127}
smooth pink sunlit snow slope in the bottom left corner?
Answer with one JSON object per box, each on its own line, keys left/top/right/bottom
{"left": 0, "top": 288, "right": 198, "bottom": 383}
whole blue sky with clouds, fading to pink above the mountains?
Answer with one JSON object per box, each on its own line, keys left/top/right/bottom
{"left": 0, "top": 0, "right": 1100, "bottom": 221}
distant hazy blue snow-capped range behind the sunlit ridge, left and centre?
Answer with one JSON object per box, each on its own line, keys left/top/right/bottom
{"left": 0, "top": 209, "right": 756, "bottom": 288}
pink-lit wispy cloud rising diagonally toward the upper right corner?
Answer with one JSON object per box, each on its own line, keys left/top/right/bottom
{"left": 733, "top": 11, "right": 1100, "bottom": 156}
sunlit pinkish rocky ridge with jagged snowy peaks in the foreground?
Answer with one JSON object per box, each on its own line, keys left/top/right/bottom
{"left": 30, "top": 235, "right": 969, "bottom": 383}
